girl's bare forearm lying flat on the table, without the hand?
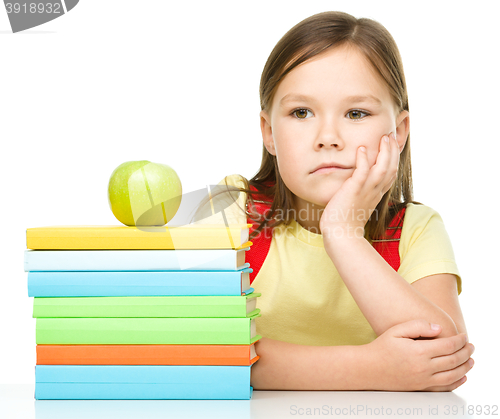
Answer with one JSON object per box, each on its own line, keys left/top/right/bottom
{"left": 251, "top": 338, "right": 376, "bottom": 390}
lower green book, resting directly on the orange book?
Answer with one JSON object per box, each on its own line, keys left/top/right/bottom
{"left": 36, "top": 313, "right": 262, "bottom": 345}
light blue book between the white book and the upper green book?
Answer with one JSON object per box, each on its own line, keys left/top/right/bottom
{"left": 28, "top": 268, "right": 253, "bottom": 297}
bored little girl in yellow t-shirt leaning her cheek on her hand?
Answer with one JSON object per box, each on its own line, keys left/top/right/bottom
{"left": 190, "top": 12, "right": 474, "bottom": 391}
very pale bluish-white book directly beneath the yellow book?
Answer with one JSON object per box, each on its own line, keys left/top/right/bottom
{"left": 24, "top": 247, "right": 250, "bottom": 272}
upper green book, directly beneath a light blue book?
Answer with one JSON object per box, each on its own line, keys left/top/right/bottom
{"left": 33, "top": 292, "right": 261, "bottom": 318}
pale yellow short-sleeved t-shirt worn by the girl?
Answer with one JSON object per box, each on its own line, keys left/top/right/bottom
{"left": 190, "top": 175, "right": 462, "bottom": 346}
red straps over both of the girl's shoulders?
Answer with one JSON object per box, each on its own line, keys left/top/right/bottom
{"left": 245, "top": 185, "right": 406, "bottom": 284}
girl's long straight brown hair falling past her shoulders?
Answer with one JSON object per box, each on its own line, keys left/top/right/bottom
{"left": 229, "top": 11, "right": 422, "bottom": 243}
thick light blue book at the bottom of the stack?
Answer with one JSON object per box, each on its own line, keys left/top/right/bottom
{"left": 35, "top": 365, "right": 253, "bottom": 400}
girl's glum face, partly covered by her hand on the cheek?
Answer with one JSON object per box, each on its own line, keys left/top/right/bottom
{"left": 261, "top": 45, "right": 409, "bottom": 218}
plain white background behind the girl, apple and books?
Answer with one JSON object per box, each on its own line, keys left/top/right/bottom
{"left": 0, "top": 0, "right": 500, "bottom": 404}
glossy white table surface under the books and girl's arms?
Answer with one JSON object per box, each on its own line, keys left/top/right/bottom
{"left": 0, "top": 383, "right": 500, "bottom": 419}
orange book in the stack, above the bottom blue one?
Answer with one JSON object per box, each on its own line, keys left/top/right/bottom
{"left": 36, "top": 342, "right": 260, "bottom": 365}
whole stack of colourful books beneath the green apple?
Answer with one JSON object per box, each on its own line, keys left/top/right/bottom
{"left": 24, "top": 224, "right": 261, "bottom": 400}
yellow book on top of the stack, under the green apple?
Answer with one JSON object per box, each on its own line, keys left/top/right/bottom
{"left": 26, "top": 224, "right": 252, "bottom": 250}
